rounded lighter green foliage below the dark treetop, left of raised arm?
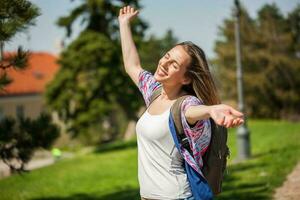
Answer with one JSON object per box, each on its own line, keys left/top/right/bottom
{"left": 46, "top": 30, "right": 129, "bottom": 141}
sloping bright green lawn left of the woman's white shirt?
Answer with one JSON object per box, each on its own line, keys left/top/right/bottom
{"left": 0, "top": 145, "right": 139, "bottom": 200}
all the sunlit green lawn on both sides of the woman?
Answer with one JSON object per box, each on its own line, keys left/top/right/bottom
{"left": 0, "top": 120, "right": 300, "bottom": 200}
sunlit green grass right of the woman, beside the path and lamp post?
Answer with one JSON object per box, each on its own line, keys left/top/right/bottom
{"left": 217, "top": 120, "right": 300, "bottom": 200}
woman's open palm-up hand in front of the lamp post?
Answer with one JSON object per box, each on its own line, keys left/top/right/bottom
{"left": 210, "top": 104, "right": 244, "bottom": 128}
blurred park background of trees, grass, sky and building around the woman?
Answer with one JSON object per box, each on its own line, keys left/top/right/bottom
{"left": 0, "top": 0, "right": 300, "bottom": 200}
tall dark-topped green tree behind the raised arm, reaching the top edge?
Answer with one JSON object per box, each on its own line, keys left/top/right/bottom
{"left": 46, "top": 0, "right": 178, "bottom": 142}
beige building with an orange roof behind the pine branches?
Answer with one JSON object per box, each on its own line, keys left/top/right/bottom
{"left": 0, "top": 52, "right": 59, "bottom": 119}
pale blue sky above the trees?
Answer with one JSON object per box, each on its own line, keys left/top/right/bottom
{"left": 5, "top": 0, "right": 300, "bottom": 58}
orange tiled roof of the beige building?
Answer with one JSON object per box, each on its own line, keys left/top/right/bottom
{"left": 0, "top": 52, "right": 59, "bottom": 96}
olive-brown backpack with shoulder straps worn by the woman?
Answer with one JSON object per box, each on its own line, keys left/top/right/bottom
{"left": 149, "top": 87, "right": 230, "bottom": 195}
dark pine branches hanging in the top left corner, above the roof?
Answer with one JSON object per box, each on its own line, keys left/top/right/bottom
{"left": 0, "top": 0, "right": 40, "bottom": 90}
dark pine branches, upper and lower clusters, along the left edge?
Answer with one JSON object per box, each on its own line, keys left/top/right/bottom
{"left": 0, "top": 0, "right": 59, "bottom": 172}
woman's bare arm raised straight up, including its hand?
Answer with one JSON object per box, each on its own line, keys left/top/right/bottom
{"left": 118, "top": 6, "right": 143, "bottom": 86}
